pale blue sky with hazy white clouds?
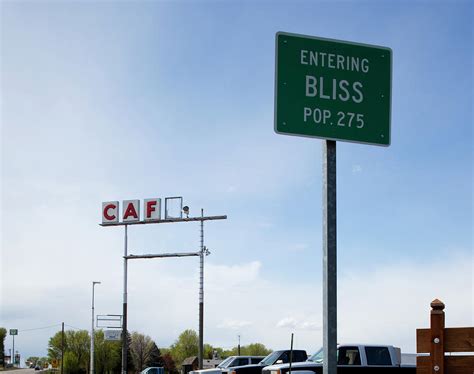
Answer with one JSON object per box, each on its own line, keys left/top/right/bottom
{"left": 0, "top": 1, "right": 474, "bottom": 364}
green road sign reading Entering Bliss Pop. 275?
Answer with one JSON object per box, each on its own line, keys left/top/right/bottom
{"left": 275, "top": 32, "right": 392, "bottom": 146}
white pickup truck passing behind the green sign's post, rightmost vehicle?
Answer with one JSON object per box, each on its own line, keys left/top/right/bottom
{"left": 262, "top": 344, "right": 416, "bottom": 374}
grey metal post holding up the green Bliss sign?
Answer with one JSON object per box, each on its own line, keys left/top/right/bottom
{"left": 323, "top": 140, "right": 337, "bottom": 374}
